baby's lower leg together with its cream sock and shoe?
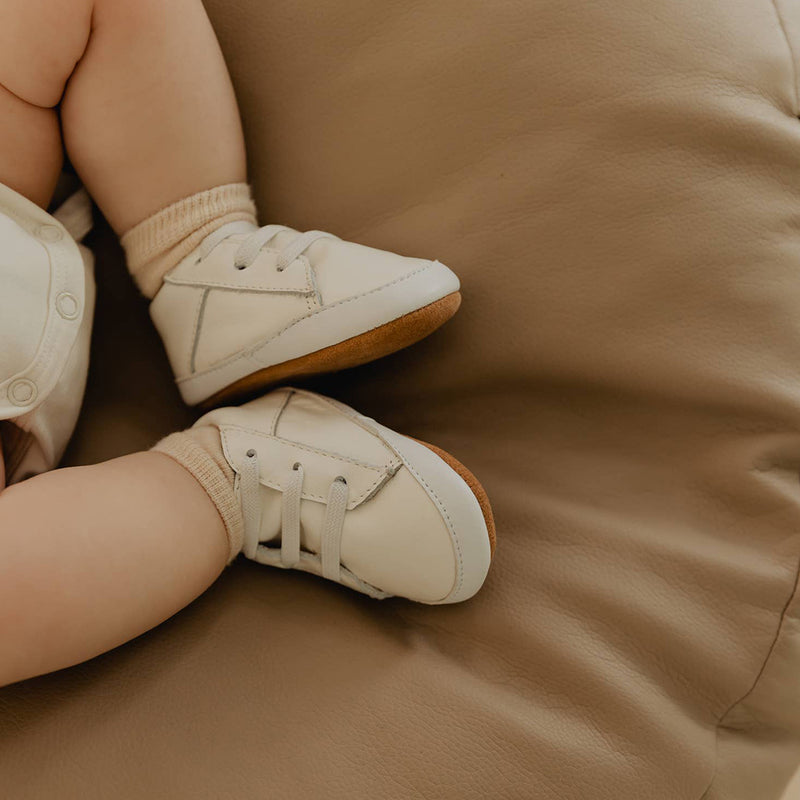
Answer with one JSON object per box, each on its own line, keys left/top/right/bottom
{"left": 0, "top": 389, "right": 495, "bottom": 685}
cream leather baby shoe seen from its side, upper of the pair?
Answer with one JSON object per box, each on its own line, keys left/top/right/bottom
{"left": 150, "top": 222, "right": 461, "bottom": 406}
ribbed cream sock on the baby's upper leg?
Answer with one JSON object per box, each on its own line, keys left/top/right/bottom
{"left": 120, "top": 183, "right": 257, "bottom": 299}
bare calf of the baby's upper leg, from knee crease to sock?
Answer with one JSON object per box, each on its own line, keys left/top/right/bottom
{"left": 61, "top": 0, "right": 246, "bottom": 233}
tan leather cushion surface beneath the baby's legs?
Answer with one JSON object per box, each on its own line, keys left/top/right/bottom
{"left": 0, "top": 0, "right": 800, "bottom": 800}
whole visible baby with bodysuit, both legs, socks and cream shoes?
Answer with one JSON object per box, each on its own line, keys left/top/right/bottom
{"left": 0, "top": 0, "right": 495, "bottom": 685}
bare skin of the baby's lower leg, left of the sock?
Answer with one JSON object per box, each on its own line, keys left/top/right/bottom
{"left": 0, "top": 452, "right": 229, "bottom": 685}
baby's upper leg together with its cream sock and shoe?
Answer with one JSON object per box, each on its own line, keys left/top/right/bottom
{"left": 0, "top": 0, "right": 460, "bottom": 412}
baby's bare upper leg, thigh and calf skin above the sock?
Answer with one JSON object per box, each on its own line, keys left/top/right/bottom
{"left": 0, "top": 0, "right": 246, "bottom": 233}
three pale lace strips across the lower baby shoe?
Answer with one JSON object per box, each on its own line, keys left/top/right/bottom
{"left": 239, "top": 450, "right": 350, "bottom": 581}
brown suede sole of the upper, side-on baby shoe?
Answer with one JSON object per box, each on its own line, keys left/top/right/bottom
{"left": 199, "top": 292, "right": 461, "bottom": 410}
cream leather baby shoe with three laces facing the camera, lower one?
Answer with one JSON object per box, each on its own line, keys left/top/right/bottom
{"left": 195, "top": 389, "right": 495, "bottom": 604}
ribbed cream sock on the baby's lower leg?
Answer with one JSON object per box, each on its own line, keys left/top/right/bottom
{"left": 152, "top": 425, "right": 244, "bottom": 563}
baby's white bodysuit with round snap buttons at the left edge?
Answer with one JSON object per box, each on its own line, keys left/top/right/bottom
{"left": 0, "top": 184, "right": 95, "bottom": 483}
